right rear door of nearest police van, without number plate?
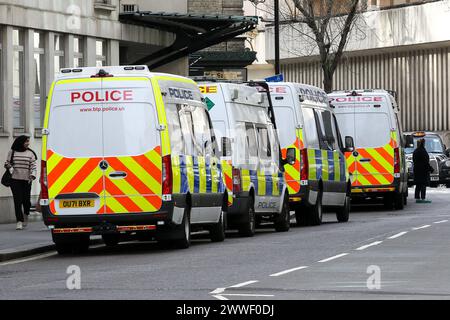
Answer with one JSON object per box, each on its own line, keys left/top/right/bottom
{"left": 102, "top": 77, "right": 162, "bottom": 213}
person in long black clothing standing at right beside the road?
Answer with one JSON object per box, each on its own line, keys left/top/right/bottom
{"left": 413, "top": 139, "right": 434, "bottom": 203}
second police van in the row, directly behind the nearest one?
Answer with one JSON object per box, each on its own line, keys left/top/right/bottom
{"left": 199, "top": 82, "right": 295, "bottom": 237}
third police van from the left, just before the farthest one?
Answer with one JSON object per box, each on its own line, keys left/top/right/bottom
{"left": 269, "top": 82, "right": 353, "bottom": 225}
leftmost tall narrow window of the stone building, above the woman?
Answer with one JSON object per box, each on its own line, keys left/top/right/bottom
{"left": 12, "top": 29, "right": 25, "bottom": 133}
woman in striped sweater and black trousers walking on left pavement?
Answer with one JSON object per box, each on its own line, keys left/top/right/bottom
{"left": 5, "top": 136, "right": 37, "bottom": 230}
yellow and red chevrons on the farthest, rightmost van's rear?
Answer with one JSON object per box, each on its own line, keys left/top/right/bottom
{"left": 345, "top": 132, "right": 397, "bottom": 187}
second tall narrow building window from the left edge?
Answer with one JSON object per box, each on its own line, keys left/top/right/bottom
{"left": 33, "top": 32, "right": 46, "bottom": 131}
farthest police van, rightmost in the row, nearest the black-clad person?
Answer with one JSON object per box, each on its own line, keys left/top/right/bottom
{"left": 329, "top": 90, "right": 408, "bottom": 209}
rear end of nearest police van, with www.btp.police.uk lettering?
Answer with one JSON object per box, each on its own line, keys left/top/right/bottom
{"left": 41, "top": 66, "right": 164, "bottom": 250}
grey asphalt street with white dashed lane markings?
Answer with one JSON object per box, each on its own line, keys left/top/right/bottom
{"left": 0, "top": 189, "right": 450, "bottom": 300}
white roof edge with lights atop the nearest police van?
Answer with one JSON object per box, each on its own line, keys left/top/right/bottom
{"left": 55, "top": 65, "right": 193, "bottom": 81}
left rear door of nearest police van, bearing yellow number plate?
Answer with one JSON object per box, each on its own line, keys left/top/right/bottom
{"left": 45, "top": 79, "right": 104, "bottom": 215}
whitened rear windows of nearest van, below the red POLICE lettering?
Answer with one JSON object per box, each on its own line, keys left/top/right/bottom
{"left": 48, "top": 102, "right": 159, "bottom": 158}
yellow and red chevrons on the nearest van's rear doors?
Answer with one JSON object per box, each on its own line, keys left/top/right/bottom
{"left": 47, "top": 146, "right": 162, "bottom": 214}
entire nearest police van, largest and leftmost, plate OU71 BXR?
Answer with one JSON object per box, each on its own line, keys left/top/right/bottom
{"left": 41, "top": 66, "right": 228, "bottom": 253}
